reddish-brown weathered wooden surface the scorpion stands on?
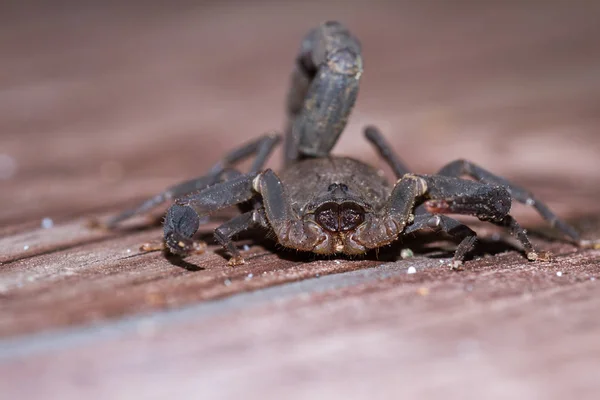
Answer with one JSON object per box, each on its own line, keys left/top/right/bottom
{"left": 0, "top": 1, "right": 600, "bottom": 399}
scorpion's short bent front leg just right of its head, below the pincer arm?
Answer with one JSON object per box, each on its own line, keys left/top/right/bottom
{"left": 403, "top": 214, "right": 477, "bottom": 268}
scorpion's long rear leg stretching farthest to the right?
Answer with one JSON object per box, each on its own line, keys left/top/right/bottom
{"left": 438, "top": 160, "right": 600, "bottom": 247}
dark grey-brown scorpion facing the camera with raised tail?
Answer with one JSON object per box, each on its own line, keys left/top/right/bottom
{"left": 106, "top": 21, "right": 600, "bottom": 268}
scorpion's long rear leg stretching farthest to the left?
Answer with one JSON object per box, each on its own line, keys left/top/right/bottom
{"left": 104, "top": 134, "right": 281, "bottom": 228}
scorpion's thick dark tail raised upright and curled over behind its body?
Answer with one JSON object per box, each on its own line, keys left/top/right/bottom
{"left": 285, "top": 21, "right": 363, "bottom": 165}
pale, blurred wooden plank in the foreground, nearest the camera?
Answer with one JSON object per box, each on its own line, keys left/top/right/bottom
{"left": 0, "top": 251, "right": 600, "bottom": 399}
